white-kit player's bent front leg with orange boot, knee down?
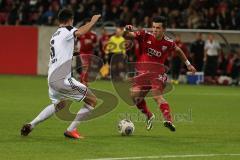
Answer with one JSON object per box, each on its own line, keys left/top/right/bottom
{"left": 64, "top": 89, "right": 97, "bottom": 139}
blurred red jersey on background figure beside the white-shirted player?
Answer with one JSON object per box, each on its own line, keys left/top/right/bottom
{"left": 79, "top": 32, "right": 97, "bottom": 54}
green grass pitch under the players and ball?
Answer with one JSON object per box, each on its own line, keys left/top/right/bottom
{"left": 0, "top": 76, "right": 240, "bottom": 160}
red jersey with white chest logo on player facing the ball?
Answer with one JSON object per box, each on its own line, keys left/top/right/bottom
{"left": 134, "top": 30, "right": 176, "bottom": 72}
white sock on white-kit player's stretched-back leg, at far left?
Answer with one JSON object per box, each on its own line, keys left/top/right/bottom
{"left": 30, "top": 104, "right": 56, "bottom": 128}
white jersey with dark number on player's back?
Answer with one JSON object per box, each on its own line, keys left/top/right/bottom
{"left": 48, "top": 26, "right": 77, "bottom": 82}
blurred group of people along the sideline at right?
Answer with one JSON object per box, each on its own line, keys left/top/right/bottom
{"left": 169, "top": 33, "right": 240, "bottom": 85}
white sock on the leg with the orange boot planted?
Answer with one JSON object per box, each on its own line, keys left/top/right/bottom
{"left": 67, "top": 103, "right": 94, "bottom": 131}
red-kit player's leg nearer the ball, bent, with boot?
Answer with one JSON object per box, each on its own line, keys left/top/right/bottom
{"left": 131, "top": 87, "right": 155, "bottom": 130}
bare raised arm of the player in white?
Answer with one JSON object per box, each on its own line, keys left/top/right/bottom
{"left": 75, "top": 14, "right": 101, "bottom": 37}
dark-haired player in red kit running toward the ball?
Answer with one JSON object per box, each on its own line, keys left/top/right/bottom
{"left": 124, "top": 16, "right": 196, "bottom": 131}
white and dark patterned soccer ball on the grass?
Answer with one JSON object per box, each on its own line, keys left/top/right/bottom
{"left": 118, "top": 119, "right": 135, "bottom": 136}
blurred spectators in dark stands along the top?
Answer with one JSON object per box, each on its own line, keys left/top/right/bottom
{"left": 0, "top": 0, "right": 240, "bottom": 29}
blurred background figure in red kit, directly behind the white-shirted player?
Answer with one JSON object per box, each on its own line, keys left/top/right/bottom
{"left": 78, "top": 25, "right": 97, "bottom": 85}
